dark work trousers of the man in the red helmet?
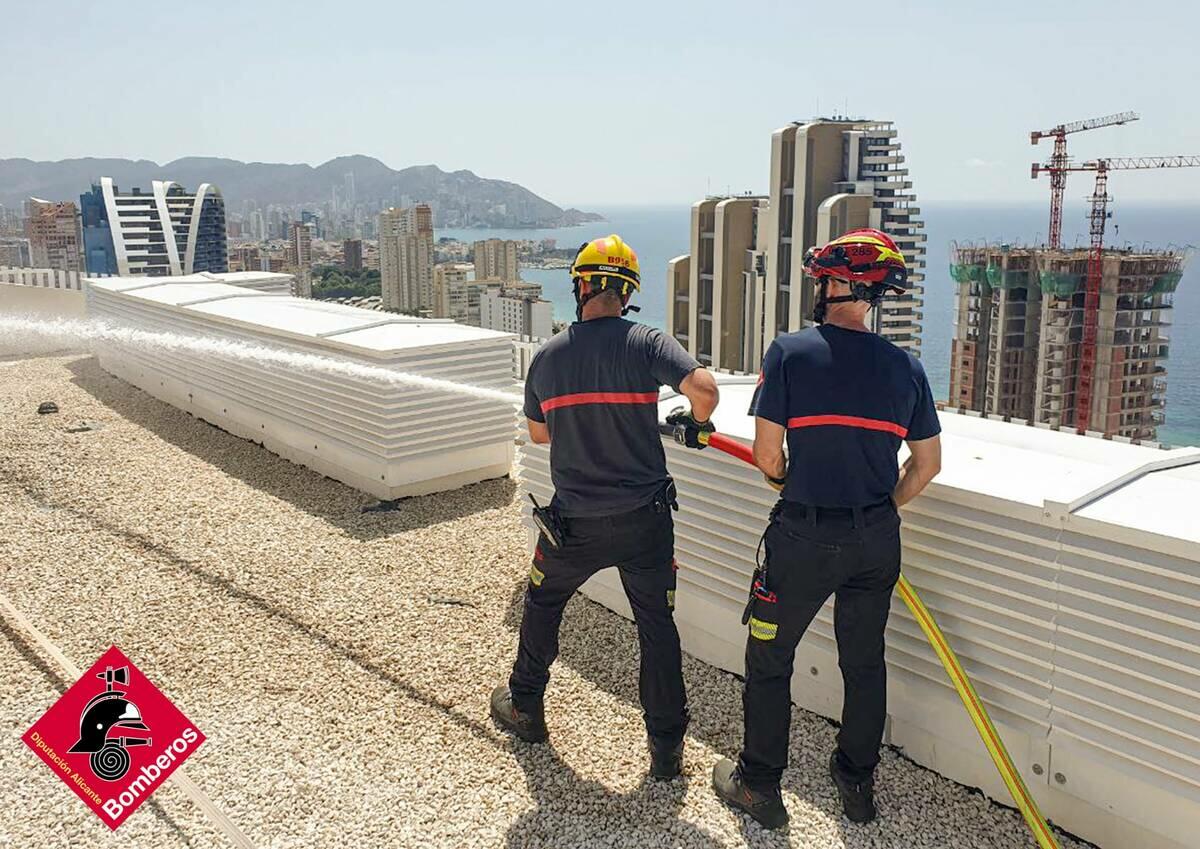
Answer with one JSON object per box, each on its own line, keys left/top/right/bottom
{"left": 739, "top": 500, "right": 900, "bottom": 789}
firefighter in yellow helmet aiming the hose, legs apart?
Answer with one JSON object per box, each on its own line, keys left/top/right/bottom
{"left": 491, "top": 235, "right": 718, "bottom": 778}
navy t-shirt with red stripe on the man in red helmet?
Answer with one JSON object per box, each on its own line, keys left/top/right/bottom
{"left": 750, "top": 324, "right": 942, "bottom": 507}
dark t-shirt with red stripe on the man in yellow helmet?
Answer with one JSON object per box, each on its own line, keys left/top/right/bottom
{"left": 524, "top": 317, "right": 700, "bottom": 516}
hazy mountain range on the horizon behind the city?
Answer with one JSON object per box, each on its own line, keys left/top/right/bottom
{"left": 0, "top": 156, "right": 602, "bottom": 228}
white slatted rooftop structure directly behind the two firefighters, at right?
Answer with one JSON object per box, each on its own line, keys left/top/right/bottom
{"left": 517, "top": 375, "right": 1200, "bottom": 849}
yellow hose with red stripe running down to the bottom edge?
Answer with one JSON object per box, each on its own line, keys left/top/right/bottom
{"left": 896, "top": 574, "right": 1060, "bottom": 849}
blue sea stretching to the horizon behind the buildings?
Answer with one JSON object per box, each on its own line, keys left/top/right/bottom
{"left": 434, "top": 201, "right": 1200, "bottom": 445}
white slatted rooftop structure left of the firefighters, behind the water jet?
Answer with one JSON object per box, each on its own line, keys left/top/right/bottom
{"left": 86, "top": 280, "right": 516, "bottom": 499}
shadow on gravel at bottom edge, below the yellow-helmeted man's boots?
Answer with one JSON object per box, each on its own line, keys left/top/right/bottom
{"left": 505, "top": 740, "right": 724, "bottom": 849}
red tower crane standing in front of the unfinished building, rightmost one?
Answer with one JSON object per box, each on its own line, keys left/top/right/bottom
{"left": 1033, "top": 156, "right": 1200, "bottom": 433}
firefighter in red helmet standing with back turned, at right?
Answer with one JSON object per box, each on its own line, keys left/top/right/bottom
{"left": 713, "top": 229, "right": 941, "bottom": 827}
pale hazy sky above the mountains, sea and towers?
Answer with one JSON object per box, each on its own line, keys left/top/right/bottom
{"left": 9, "top": 0, "right": 1200, "bottom": 205}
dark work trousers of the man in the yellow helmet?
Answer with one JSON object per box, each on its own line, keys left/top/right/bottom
{"left": 509, "top": 502, "right": 688, "bottom": 745}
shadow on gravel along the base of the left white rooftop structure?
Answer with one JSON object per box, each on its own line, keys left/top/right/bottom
{"left": 67, "top": 356, "right": 516, "bottom": 541}
